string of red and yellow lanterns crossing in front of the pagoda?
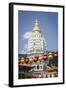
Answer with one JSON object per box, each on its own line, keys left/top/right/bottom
{"left": 19, "top": 52, "right": 58, "bottom": 64}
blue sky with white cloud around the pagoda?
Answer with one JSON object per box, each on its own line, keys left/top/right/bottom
{"left": 18, "top": 11, "right": 58, "bottom": 54}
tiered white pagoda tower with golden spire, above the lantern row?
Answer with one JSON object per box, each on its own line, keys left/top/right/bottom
{"left": 27, "top": 19, "right": 46, "bottom": 55}
